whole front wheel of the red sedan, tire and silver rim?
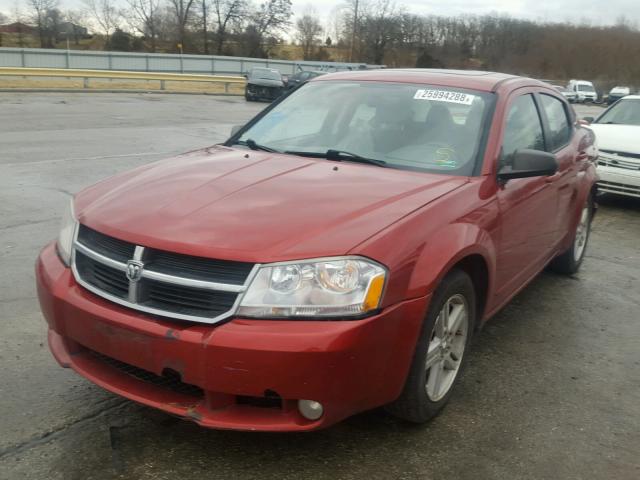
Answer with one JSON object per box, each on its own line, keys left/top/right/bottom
{"left": 387, "top": 270, "right": 476, "bottom": 423}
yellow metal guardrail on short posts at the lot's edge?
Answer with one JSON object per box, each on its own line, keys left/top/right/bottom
{"left": 0, "top": 67, "right": 246, "bottom": 93}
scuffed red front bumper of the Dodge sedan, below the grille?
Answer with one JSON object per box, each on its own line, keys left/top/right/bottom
{"left": 36, "top": 245, "right": 429, "bottom": 431}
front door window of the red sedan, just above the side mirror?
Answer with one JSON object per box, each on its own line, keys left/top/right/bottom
{"left": 502, "top": 95, "right": 544, "bottom": 164}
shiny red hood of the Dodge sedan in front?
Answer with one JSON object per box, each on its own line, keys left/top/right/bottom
{"left": 75, "top": 146, "right": 468, "bottom": 262}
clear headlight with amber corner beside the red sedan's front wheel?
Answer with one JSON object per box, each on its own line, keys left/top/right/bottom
{"left": 238, "top": 257, "right": 387, "bottom": 318}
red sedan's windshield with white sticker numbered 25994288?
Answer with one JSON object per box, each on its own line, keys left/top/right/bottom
{"left": 238, "top": 81, "right": 494, "bottom": 175}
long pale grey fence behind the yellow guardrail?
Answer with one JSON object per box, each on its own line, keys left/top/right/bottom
{"left": 0, "top": 48, "right": 380, "bottom": 75}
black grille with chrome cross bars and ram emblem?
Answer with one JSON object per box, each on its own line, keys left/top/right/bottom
{"left": 72, "top": 225, "right": 257, "bottom": 323}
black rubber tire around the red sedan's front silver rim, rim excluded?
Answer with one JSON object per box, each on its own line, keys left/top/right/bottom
{"left": 386, "top": 269, "right": 476, "bottom": 423}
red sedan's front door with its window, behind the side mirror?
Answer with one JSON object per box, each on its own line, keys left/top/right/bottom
{"left": 496, "top": 90, "right": 558, "bottom": 303}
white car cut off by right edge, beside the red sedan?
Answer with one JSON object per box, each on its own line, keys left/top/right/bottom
{"left": 585, "top": 95, "right": 640, "bottom": 198}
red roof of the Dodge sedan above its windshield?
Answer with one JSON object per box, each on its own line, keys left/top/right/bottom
{"left": 311, "top": 68, "right": 551, "bottom": 92}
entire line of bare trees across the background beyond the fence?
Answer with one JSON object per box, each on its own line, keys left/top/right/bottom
{"left": 5, "top": 0, "right": 640, "bottom": 86}
